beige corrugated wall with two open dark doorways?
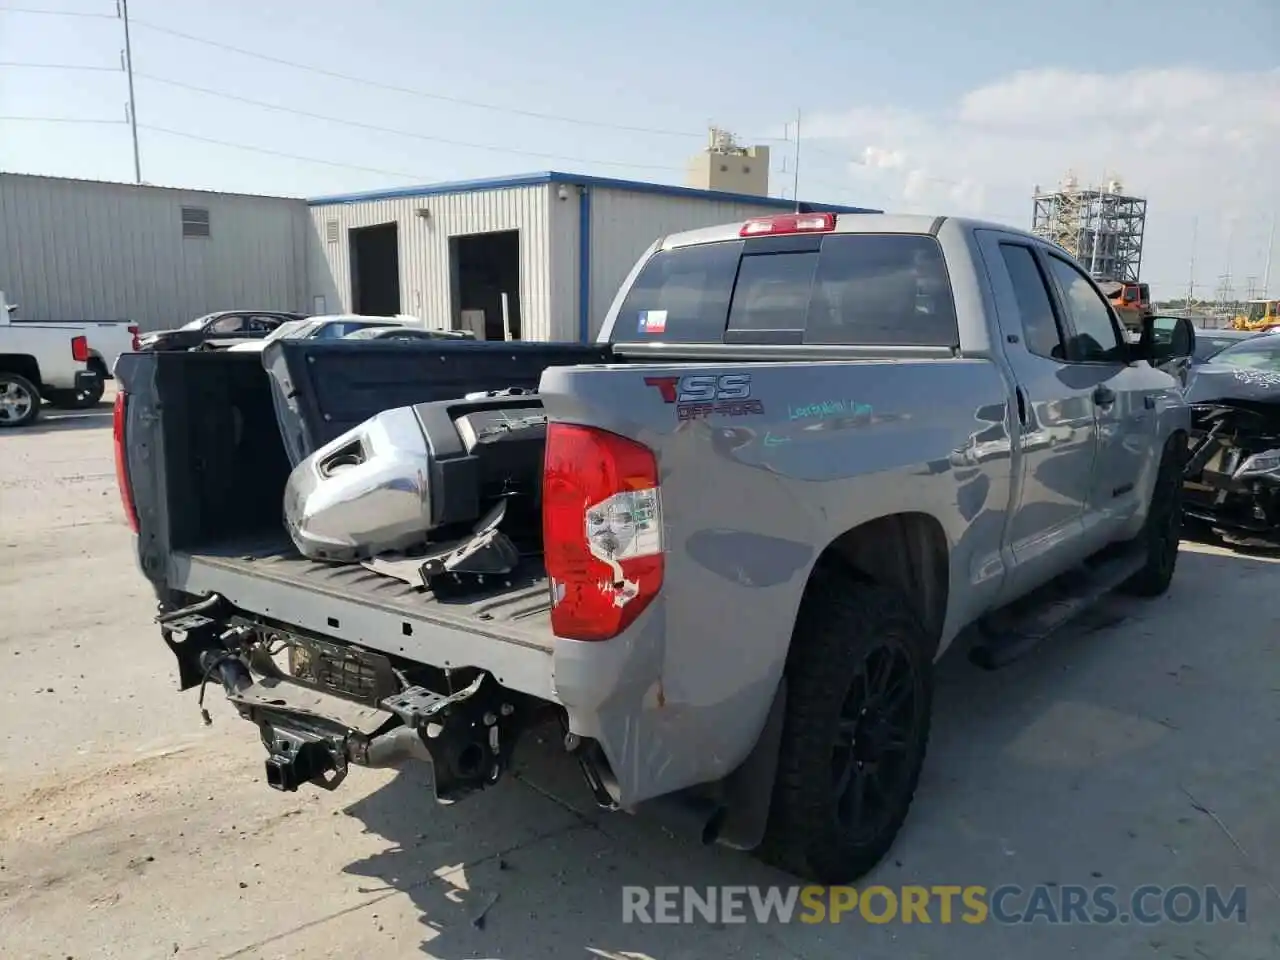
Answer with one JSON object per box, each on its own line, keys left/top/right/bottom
{"left": 308, "top": 186, "right": 560, "bottom": 340}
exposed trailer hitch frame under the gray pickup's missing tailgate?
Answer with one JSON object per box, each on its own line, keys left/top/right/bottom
{"left": 204, "top": 650, "right": 525, "bottom": 804}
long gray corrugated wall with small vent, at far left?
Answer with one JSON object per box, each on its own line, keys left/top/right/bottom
{"left": 0, "top": 174, "right": 308, "bottom": 330}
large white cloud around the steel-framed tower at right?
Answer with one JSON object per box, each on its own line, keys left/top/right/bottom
{"left": 805, "top": 68, "right": 1280, "bottom": 296}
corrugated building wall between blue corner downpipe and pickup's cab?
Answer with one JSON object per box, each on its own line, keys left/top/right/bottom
{"left": 586, "top": 187, "right": 785, "bottom": 338}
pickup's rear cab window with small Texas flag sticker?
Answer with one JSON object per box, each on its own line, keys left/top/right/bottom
{"left": 612, "top": 233, "right": 959, "bottom": 347}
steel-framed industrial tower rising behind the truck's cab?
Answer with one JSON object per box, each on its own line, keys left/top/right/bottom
{"left": 1032, "top": 174, "right": 1147, "bottom": 283}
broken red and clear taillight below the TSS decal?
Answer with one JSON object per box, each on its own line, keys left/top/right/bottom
{"left": 543, "top": 424, "right": 663, "bottom": 640}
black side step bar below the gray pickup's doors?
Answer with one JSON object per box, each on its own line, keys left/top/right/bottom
{"left": 969, "top": 549, "right": 1146, "bottom": 669}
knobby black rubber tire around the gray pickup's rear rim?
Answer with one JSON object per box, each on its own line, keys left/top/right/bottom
{"left": 759, "top": 571, "right": 934, "bottom": 883}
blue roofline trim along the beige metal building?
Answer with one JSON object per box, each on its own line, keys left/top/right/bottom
{"left": 307, "top": 170, "right": 884, "bottom": 214}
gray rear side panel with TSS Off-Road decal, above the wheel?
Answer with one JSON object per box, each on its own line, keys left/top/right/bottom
{"left": 539, "top": 358, "right": 1011, "bottom": 806}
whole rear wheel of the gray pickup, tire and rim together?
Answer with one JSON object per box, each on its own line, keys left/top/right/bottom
{"left": 762, "top": 573, "right": 933, "bottom": 883}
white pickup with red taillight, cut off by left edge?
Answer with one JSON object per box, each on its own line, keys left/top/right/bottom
{"left": 0, "top": 292, "right": 102, "bottom": 430}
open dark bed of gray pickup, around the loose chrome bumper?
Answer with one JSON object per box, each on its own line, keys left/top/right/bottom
{"left": 111, "top": 340, "right": 624, "bottom": 701}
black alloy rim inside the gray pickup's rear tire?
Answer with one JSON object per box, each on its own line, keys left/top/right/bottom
{"left": 832, "top": 640, "right": 922, "bottom": 842}
